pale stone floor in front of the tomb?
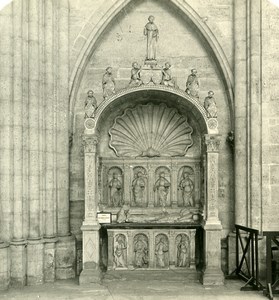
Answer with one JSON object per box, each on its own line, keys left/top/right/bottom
{"left": 0, "top": 270, "right": 267, "bottom": 300}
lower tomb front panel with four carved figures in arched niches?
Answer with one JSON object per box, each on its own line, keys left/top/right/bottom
{"left": 107, "top": 228, "right": 196, "bottom": 270}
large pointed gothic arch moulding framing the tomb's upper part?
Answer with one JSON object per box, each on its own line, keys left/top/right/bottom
{"left": 69, "top": 0, "right": 234, "bottom": 131}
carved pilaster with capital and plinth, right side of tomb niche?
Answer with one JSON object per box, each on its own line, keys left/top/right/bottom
{"left": 202, "top": 134, "right": 224, "bottom": 285}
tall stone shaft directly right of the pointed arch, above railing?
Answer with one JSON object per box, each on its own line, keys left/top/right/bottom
{"left": 234, "top": 0, "right": 249, "bottom": 226}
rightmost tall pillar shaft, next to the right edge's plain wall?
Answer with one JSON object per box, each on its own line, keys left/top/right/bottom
{"left": 249, "top": 0, "right": 262, "bottom": 230}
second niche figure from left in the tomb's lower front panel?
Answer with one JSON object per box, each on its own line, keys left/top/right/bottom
{"left": 133, "top": 234, "right": 149, "bottom": 268}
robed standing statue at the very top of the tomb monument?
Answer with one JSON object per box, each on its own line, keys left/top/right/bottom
{"left": 143, "top": 16, "right": 159, "bottom": 61}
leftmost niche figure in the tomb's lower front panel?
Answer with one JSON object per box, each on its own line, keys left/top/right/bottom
{"left": 113, "top": 234, "right": 127, "bottom": 268}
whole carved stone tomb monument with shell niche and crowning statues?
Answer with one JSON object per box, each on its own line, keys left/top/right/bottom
{"left": 80, "top": 16, "right": 223, "bottom": 284}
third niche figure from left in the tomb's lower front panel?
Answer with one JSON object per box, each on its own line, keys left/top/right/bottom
{"left": 155, "top": 234, "right": 169, "bottom": 268}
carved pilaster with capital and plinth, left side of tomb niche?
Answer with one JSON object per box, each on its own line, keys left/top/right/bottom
{"left": 79, "top": 134, "right": 101, "bottom": 284}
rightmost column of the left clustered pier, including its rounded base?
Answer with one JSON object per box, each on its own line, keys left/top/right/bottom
{"left": 53, "top": 0, "right": 76, "bottom": 279}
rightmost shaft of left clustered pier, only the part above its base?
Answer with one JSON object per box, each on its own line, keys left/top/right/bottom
{"left": 56, "top": 0, "right": 70, "bottom": 236}
